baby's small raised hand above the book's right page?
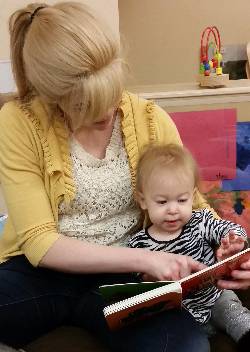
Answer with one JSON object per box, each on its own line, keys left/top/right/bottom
{"left": 216, "top": 231, "right": 246, "bottom": 261}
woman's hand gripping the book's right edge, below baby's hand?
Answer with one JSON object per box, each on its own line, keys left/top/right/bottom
{"left": 217, "top": 259, "right": 250, "bottom": 290}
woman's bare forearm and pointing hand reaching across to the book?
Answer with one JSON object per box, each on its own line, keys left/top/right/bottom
{"left": 39, "top": 235, "right": 204, "bottom": 280}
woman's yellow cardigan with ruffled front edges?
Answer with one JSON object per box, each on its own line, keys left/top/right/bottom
{"left": 0, "top": 92, "right": 211, "bottom": 266}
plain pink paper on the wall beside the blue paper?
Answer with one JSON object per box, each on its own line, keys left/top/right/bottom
{"left": 169, "top": 109, "right": 237, "bottom": 181}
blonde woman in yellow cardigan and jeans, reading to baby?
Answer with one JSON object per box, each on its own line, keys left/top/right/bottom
{"left": 0, "top": 2, "right": 250, "bottom": 352}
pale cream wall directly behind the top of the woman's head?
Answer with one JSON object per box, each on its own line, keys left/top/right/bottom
{"left": 0, "top": 0, "right": 119, "bottom": 60}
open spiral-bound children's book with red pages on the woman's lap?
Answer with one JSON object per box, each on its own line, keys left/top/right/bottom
{"left": 99, "top": 248, "right": 250, "bottom": 330}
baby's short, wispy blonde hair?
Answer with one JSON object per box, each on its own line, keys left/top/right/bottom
{"left": 136, "top": 144, "right": 200, "bottom": 192}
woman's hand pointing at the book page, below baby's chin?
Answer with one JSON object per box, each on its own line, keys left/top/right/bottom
{"left": 142, "top": 251, "right": 206, "bottom": 281}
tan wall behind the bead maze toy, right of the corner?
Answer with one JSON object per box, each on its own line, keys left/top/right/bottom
{"left": 119, "top": 0, "right": 250, "bottom": 85}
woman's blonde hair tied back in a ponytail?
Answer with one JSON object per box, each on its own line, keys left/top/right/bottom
{"left": 9, "top": 2, "right": 124, "bottom": 129}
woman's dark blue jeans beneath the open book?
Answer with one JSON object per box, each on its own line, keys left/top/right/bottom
{"left": 0, "top": 256, "right": 209, "bottom": 352}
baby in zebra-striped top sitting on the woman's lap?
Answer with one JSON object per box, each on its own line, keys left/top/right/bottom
{"left": 129, "top": 144, "right": 250, "bottom": 350}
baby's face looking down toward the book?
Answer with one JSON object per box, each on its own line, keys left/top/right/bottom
{"left": 139, "top": 167, "right": 194, "bottom": 235}
